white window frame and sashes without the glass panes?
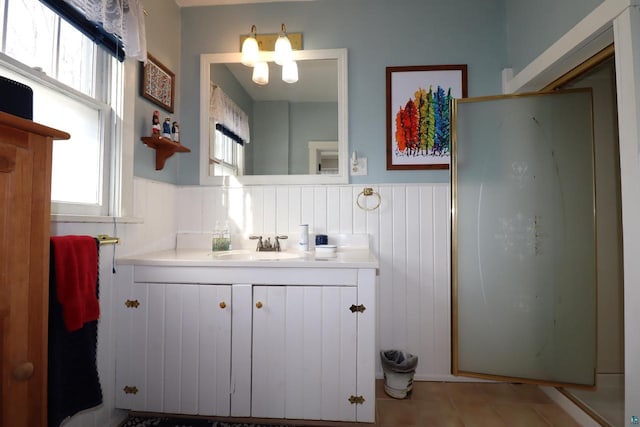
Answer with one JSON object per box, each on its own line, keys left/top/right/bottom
{"left": 0, "top": 0, "right": 137, "bottom": 222}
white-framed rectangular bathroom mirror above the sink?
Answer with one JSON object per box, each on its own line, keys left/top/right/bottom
{"left": 200, "top": 49, "right": 348, "bottom": 185}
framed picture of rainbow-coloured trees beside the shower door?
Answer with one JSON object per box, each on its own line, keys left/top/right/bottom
{"left": 386, "top": 64, "right": 467, "bottom": 170}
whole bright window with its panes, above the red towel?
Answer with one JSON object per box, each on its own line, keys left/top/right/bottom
{"left": 0, "top": 0, "right": 123, "bottom": 215}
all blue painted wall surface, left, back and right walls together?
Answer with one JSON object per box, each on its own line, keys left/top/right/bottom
{"left": 139, "top": 0, "right": 604, "bottom": 184}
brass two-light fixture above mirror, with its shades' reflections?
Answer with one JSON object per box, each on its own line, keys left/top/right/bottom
{"left": 241, "top": 23, "right": 302, "bottom": 85}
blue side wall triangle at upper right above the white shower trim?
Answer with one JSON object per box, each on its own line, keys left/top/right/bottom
{"left": 505, "top": 0, "right": 604, "bottom": 74}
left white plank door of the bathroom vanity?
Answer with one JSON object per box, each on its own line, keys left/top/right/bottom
{"left": 116, "top": 283, "right": 231, "bottom": 415}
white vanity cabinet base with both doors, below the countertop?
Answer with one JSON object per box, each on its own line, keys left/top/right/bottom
{"left": 116, "top": 252, "right": 377, "bottom": 422}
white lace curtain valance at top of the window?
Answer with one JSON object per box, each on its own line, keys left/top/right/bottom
{"left": 64, "top": 0, "right": 147, "bottom": 62}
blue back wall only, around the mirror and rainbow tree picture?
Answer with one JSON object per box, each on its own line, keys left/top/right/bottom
{"left": 178, "top": 0, "right": 507, "bottom": 184}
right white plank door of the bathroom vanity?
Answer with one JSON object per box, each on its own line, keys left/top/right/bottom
{"left": 251, "top": 286, "right": 357, "bottom": 421}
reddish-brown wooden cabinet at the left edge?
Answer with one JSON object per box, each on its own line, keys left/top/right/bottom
{"left": 0, "top": 112, "right": 69, "bottom": 426}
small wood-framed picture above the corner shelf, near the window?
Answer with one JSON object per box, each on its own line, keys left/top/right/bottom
{"left": 140, "top": 53, "right": 176, "bottom": 113}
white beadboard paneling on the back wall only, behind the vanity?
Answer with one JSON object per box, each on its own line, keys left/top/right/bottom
{"left": 176, "top": 184, "right": 455, "bottom": 380}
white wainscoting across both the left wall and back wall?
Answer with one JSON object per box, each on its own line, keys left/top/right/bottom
{"left": 51, "top": 178, "right": 457, "bottom": 427}
